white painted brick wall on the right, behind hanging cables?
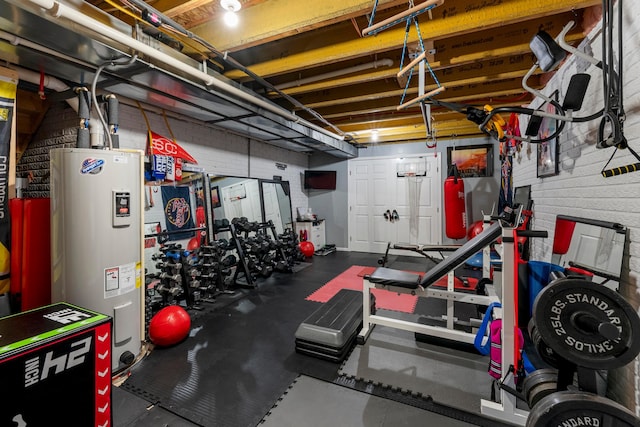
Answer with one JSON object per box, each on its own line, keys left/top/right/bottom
{"left": 513, "top": 0, "right": 640, "bottom": 415}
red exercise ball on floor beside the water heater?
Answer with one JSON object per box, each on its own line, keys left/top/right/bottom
{"left": 149, "top": 305, "right": 191, "bottom": 347}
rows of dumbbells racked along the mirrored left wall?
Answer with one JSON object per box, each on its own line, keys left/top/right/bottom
{"left": 145, "top": 217, "right": 304, "bottom": 342}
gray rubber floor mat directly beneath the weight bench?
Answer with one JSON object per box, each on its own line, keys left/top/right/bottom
{"left": 338, "top": 311, "right": 491, "bottom": 414}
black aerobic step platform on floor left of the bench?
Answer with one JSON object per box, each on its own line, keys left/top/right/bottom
{"left": 295, "top": 289, "right": 375, "bottom": 362}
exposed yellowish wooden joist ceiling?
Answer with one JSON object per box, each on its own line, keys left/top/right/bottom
{"left": 77, "top": 0, "right": 601, "bottom": 144}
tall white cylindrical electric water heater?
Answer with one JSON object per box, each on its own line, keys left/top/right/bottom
{"left": 51, "top": 148, "right": 144, "bottom": 370}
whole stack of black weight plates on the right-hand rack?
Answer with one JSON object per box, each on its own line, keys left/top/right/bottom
{"left": 522, "top": 273, "right": 640, "bottom": 427}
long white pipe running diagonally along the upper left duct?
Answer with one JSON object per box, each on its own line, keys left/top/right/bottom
{"left": 26, "top": 0, "right": 343, "bottom": 139}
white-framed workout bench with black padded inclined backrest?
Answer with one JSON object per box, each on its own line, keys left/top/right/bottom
{"left": 358, "top": 221, "right": 501, "bottom": 344}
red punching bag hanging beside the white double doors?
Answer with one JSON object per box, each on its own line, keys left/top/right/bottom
{"left": 444, "top": 164, "right": 467, "bottom": 239}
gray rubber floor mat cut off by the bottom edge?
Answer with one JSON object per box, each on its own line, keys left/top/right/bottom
{"left": 260, "top": 376, "right": 473, "bottom": 427}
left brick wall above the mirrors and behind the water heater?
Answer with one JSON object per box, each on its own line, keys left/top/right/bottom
{"left": 17, "top": 102, "right": 309, "bottom": 210}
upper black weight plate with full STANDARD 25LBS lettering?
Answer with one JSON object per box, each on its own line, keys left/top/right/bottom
{"left": 533, "top": 278, "right": 640, "bottom": 369}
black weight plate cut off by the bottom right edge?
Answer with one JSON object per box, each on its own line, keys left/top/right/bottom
{"left": 526, "top": 391, "right": 640, "bottom": 427}
